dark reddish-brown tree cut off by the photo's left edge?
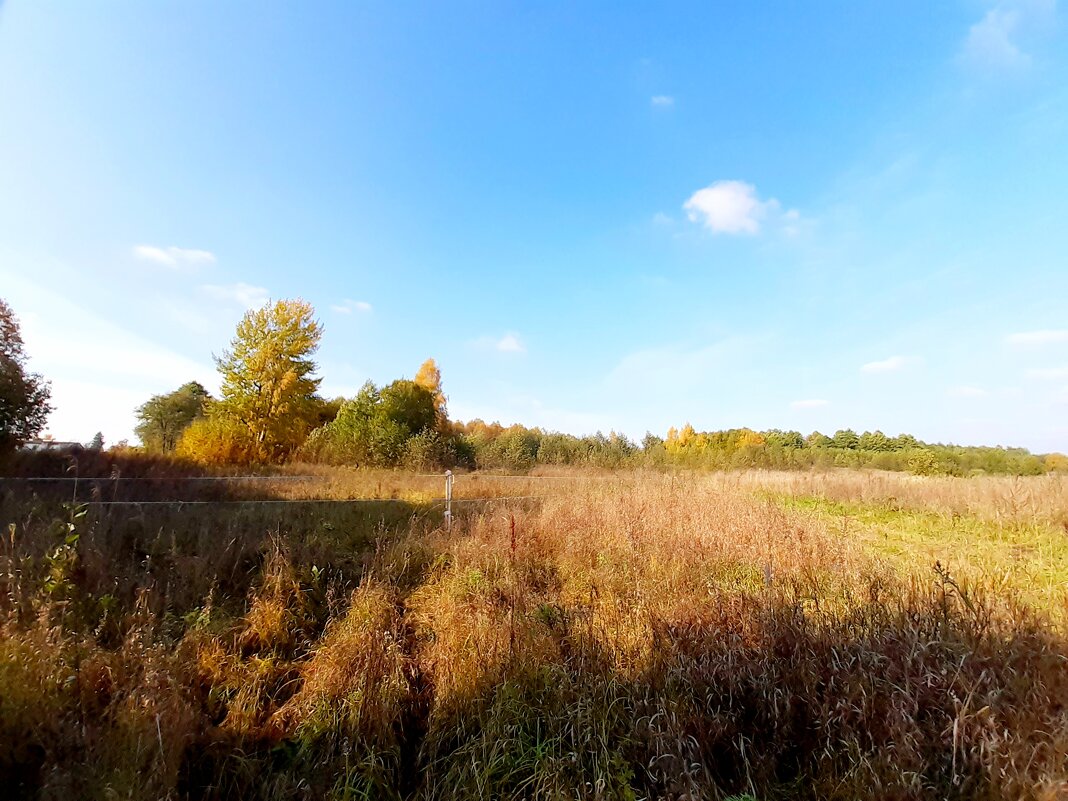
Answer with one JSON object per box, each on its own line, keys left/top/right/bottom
{"left": 0, "top": 299, "right": 52, "bottom": 451}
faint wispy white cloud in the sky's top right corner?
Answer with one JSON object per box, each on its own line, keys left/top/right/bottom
{"left": 961, "top": 0, "right": 1056, "bottom": 70}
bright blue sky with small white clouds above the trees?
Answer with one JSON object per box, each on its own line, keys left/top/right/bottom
{"left": 0, "top": 0, "right": 1068, "bottom": 452}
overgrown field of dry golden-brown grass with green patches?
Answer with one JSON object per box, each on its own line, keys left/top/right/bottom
{"left": 0, "top": 464, "right": 1068, "bottom": 799}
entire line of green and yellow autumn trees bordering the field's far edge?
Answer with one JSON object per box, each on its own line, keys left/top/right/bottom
{"left": 0, "top": 299, "right": 1068, "bottom": 475}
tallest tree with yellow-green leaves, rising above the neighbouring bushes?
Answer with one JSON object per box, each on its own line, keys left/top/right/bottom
{"left": 213, "top": 300, "right": 323, "bottom": 461}
